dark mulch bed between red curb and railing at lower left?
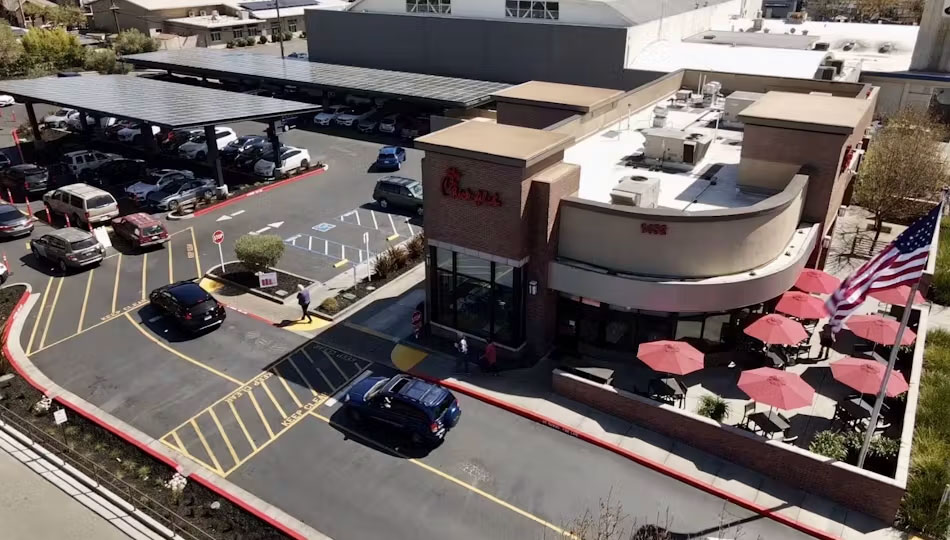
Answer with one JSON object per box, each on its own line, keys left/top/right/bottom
{"left": 0, "top": 287, "right": 287, "bottom": 540}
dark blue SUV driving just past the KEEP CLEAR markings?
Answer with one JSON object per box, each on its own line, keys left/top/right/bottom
{"left": 343, "top": 374, "right": 462, "bottom": 445}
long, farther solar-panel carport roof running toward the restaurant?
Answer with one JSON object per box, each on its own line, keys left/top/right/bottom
{"left": 122, "top": 47, "right": 510, "bottom": 107}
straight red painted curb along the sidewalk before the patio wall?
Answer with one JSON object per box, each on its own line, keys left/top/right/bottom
{"left": 411, "top": 372, "right": 841, "bottom": 540}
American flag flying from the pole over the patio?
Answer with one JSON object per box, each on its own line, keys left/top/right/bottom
{"left": 825, "top": 205, "right": 941, "bottom": 332}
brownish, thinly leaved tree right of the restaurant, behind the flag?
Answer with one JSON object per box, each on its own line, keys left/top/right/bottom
{"left": 854, "top": 108, "right": 947, "bottom": 244}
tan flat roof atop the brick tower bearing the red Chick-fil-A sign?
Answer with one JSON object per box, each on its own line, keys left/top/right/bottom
{"left": 415, "top": 122, "right": 574, "bottom": 166}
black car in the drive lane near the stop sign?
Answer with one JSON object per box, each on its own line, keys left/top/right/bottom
{"left": 148, "top": 281, "right": 227, "bottom": 332}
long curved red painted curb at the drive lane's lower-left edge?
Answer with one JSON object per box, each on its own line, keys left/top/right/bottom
{"left": 2, "top": 292, "right": 314, "bottom": 540}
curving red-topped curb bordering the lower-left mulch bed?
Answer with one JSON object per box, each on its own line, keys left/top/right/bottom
{"left": 2, "top": 283, "right": 330, "bottom": 540}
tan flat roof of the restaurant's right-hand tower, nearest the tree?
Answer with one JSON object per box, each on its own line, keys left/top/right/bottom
{"left": 739, "top": 92, "right": 871, "bottom": 133}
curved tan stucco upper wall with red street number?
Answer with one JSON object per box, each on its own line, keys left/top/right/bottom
{"left": 558, "top": 176, "right": 808, "bottom": 278}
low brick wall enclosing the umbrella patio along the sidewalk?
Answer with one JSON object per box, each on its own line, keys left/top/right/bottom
{"left": 552, "top": 370, "right": 904, "bottom": 523}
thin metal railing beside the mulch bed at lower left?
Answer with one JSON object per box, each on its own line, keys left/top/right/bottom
{"left": 0, "top": 405, "right": 216, "bottom": 540}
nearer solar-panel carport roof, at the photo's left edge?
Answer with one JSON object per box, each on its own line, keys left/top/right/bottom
{"left": 0, "top": 75, "right": 320, "bottom": 128}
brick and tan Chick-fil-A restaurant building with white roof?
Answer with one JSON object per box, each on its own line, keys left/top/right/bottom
{"left": 416, "top": 70, "right": 877, "bottom": 359}
